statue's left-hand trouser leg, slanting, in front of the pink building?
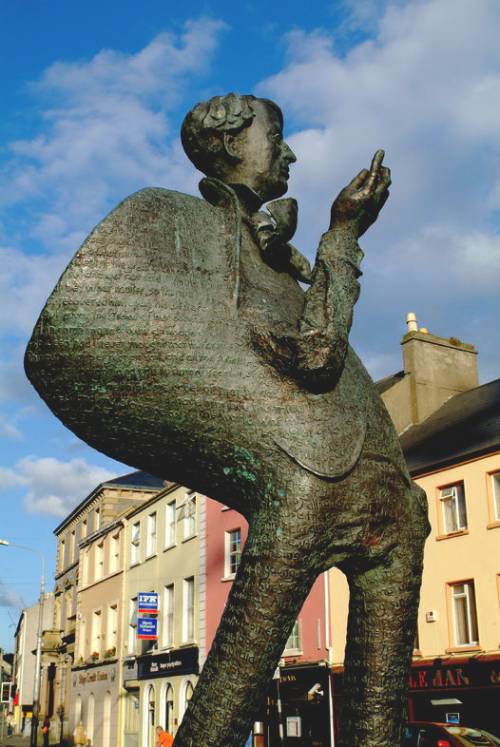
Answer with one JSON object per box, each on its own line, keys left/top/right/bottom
{"left": 175, "top": 516, "right": 317, "bottom": 747}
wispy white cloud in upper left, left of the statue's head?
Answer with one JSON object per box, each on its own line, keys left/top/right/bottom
{"left": 0, "top": 19, "right": 225, "bottom": 251}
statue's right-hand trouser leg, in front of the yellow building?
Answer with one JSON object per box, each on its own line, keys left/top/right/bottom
{"left": 338, "top": 487, "right": 428, "bottom": 747}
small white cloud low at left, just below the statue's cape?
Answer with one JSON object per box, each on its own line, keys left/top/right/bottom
{"left": 0, "top": 456, "right": 116, "bottom": 516}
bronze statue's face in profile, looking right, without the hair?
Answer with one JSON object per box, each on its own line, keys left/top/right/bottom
{"left": 230, "top": 100, "right": 297, "bottom": 202}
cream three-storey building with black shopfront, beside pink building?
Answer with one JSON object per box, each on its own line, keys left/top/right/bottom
{"left": 122, "top": 484, "right": 205, "bottom": 747}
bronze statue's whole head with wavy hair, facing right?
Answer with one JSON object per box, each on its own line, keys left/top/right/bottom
{"left": 181, "top": 93, "right": 297, "bottom": 202}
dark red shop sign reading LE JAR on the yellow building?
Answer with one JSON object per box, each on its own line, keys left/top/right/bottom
{"left": 409, "top": 661, "right": 500, "bottom": 691}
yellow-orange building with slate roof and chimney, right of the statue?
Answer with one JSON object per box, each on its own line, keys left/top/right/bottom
{"left": 330, "top": 318, "right": 500, "bottom": 734}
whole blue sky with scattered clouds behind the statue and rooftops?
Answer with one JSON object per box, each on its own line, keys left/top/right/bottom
{"left": 0, "top": 0, "right": 500, "bottom": 648}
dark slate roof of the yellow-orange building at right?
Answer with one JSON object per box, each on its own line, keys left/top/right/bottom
{"left": 401, "top": 379, "right": 500, "bottom": 475}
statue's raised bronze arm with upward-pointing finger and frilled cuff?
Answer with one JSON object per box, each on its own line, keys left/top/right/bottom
{"left": 254, "top": 151, "right": 391, "bottom": 390}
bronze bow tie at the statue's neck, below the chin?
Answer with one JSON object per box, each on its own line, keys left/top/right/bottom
{"left": 248, "top": 197, "right": 311, "bottom": 283}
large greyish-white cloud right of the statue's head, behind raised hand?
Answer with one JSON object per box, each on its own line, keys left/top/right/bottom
{"left": 258, "top": 0, "right": 500, "bottom": 376}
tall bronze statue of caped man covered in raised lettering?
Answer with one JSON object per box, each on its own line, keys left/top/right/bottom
{"left": 26, "top": 94, "right": 428, "bottom": 747}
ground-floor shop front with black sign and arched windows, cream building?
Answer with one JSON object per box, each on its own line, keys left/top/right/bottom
{"left": 136, "top": 646, "right": 199, "bottom": 747}
